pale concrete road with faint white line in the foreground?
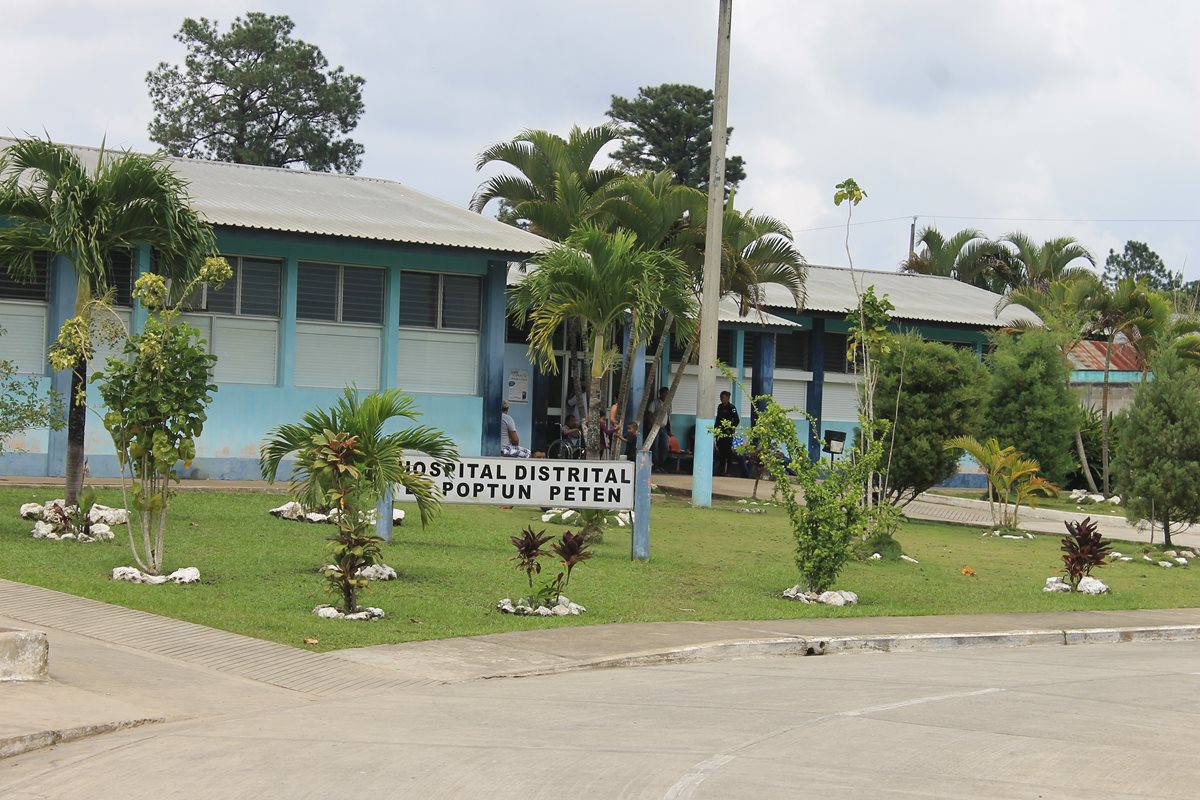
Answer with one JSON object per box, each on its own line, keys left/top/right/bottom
{"left": 0, "top": 642, "right": 1200, "bottom": 800}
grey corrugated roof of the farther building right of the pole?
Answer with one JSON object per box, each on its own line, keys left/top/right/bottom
{"left": 766, "top": 265, "right": 1042, "bottom": 327}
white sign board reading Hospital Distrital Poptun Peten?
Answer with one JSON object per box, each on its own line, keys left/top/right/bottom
{"left": 395, "top": 456, "right": 634, "bottom": 510}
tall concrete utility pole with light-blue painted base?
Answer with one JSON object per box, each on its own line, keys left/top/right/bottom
{"left": 691, "top": 0, "right": 733, "bottom": 509}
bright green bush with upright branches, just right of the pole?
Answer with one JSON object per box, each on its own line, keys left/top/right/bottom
{"left": 740, "top": 395, "right": 887, "bottom": 594}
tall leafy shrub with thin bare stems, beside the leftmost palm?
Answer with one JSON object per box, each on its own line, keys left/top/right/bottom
{"left": 91, "top": 266, "right": 233, "bottom": 575}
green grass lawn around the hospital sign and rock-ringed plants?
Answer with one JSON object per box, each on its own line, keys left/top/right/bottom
{"left": 0, "top": 489, "right": 1200, "bottom": 650}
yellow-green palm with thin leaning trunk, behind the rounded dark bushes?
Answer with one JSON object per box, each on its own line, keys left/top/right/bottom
{"left": 996, "top": 270, "right": 1104, "bottom": 494}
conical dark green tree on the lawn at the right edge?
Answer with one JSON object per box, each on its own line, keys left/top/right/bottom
{"left": 1114, "top": 350, "right": 1200, "bottom": 546}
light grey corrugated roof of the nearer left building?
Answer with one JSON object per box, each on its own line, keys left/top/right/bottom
{"left": 0, "top": 137, "right": 551, "bottom": 255}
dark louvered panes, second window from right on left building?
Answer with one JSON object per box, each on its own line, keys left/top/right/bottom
{"left": 296, "top": 263, "right": 384, "bottom": 325}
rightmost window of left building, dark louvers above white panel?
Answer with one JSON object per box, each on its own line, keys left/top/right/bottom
{"left": 397, "top": 271, "right": 484, "bottom": 395}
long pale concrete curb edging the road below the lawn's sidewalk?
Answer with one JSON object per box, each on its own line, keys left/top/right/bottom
{"left": 481, "top": 625, "right": 1200, "bottom": 680}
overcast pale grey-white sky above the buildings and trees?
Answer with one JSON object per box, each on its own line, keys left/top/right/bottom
{"left": 0, "top": 0, "right": 1200, "bottom": 278}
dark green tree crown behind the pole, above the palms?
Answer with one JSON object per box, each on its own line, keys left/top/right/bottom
{"left": 608, "top": 83, "right": 746, "bottom": 193}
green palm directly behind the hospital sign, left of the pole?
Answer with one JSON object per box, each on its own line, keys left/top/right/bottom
{"left": 509, "top": 224, "right": 692, "bottom": 458}
